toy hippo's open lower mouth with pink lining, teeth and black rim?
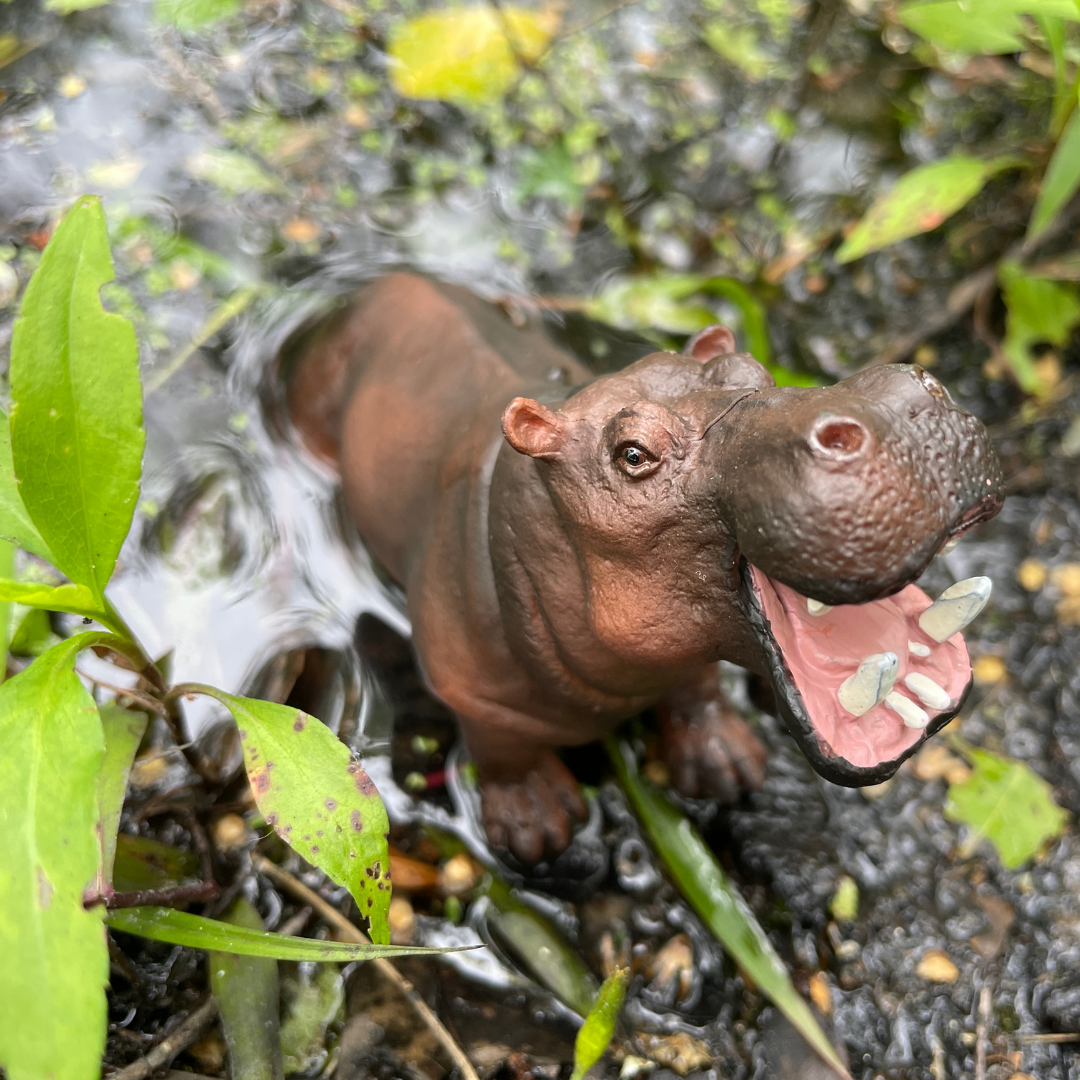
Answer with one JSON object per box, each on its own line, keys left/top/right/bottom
{"left": 741, "top": 559, "right": 989, "bottom": 787}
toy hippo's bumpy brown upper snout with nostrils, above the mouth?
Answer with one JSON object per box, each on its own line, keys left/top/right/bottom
{"left": 721, "top": 366, "right": 1003, "bottom": 605}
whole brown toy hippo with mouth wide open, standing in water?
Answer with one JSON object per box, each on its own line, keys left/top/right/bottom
{"left": 286, "top": 273, "right": 1002, "bottom": 862}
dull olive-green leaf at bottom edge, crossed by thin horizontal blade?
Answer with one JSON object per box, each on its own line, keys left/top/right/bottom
{"left": 206, "top": 896, "right": 285, "bottom": 1080}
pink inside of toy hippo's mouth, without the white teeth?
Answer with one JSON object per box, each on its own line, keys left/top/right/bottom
{"left": 751, "top": 566, "right": 971, "bottom": 768}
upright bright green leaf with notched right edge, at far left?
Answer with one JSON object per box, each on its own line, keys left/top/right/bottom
{"left": 11, "top": 195, "right": 145, "bottom": 608}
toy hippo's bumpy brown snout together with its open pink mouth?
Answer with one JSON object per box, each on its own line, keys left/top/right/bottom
{"left": 715, "top": 365, "right": 1003, "bottom": 786}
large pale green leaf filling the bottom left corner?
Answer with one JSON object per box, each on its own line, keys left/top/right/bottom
{"left": 0, "top": 634, "right": 112, "bottom": 1080}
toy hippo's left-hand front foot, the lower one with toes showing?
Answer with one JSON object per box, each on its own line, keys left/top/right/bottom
{"left": 480, "top": 750, "right": 589, "bottom": 865}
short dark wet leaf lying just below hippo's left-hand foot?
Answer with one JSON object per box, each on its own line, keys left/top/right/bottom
{"left": 486, "top": 876, "right": 596, "bottom": 1016}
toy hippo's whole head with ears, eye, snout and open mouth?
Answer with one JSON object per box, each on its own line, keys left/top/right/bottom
{"left": 503, "top": 327, "right": 1002, "bottom": 786}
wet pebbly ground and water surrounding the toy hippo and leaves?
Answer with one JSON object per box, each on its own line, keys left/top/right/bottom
{"left": 0, "top": 0, "right": 1080, "bottom": 1080}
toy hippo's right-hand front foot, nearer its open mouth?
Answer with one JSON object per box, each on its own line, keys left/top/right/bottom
{"left": 657, "top": 664, "right": 766, "bottom": 802}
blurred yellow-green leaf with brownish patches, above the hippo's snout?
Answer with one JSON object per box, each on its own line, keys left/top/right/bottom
{"left": 836, "top": 153, "right": 1017, "bottom": 262}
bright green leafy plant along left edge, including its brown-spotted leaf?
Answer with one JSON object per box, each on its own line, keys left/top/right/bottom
{"left": 0, "top": 197, "right": 412, "bottom": 1080}
